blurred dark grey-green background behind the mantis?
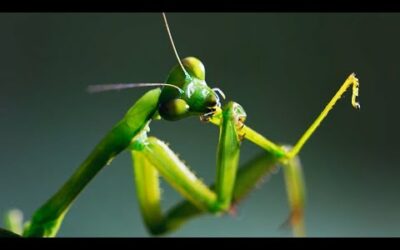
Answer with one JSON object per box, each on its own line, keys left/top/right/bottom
{"left": 0, "top": 13, "right": 400, "bottom": 236}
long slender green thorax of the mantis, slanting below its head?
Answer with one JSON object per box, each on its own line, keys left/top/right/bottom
{"left": 24, "top": 89, "right": 161, "bottom": 237}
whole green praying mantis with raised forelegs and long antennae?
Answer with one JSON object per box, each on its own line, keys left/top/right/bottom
{"left": 0, "top": 13, "right": 360, "bottom": 237}
